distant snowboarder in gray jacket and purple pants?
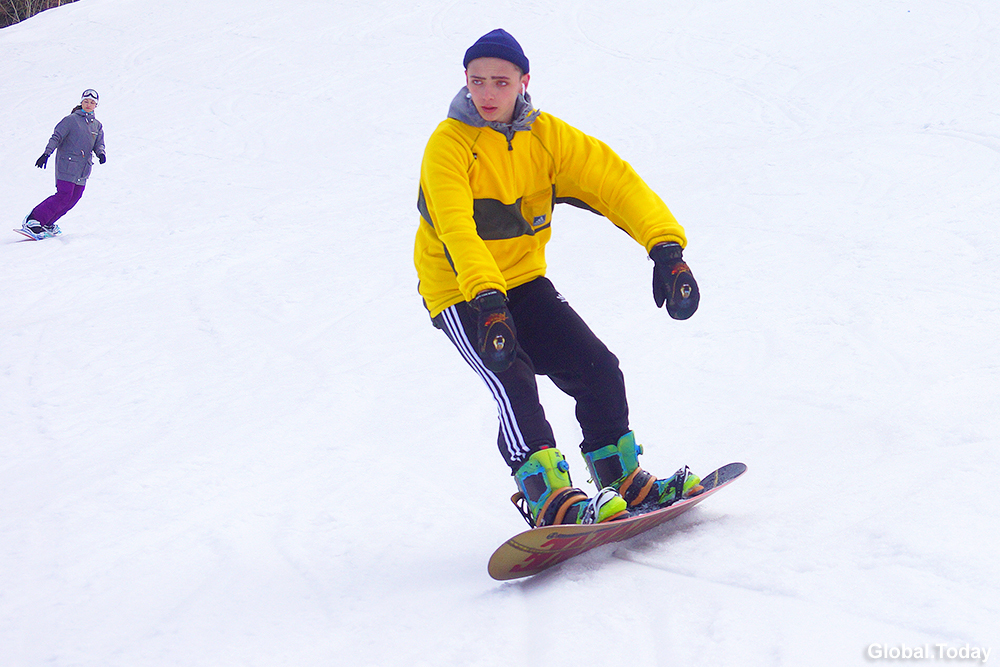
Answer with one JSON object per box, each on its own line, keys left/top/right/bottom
{"left": 21, "top": 88, "right": 107, "bottom": 239}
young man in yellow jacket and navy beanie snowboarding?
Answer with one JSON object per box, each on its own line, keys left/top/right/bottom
{"left": 414, "top": 29, "right": 700, "bottom": 526}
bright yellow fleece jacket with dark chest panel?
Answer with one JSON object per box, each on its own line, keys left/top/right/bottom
{"left": 414, "top": 100, "right": 687, "bottom": 317}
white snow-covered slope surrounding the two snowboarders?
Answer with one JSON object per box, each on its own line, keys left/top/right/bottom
{"left": 0, "top": 0, "right": 1000, "bottom": 667}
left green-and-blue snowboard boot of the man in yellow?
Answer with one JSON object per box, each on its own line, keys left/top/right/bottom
{"left": 510, "top": 447, "right": 628, "bottom": 528}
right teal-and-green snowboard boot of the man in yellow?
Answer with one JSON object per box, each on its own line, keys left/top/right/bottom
{"left": 583, "top": 431, "right": 704, "bottom": 510}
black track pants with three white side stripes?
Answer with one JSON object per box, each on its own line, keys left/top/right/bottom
{"left": 434, "top": 278, "right": 629, "bottom": 470}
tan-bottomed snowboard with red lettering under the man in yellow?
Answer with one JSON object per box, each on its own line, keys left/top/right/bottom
{"left": 489, "top": 463, "right": 747, "bottom": 581}
